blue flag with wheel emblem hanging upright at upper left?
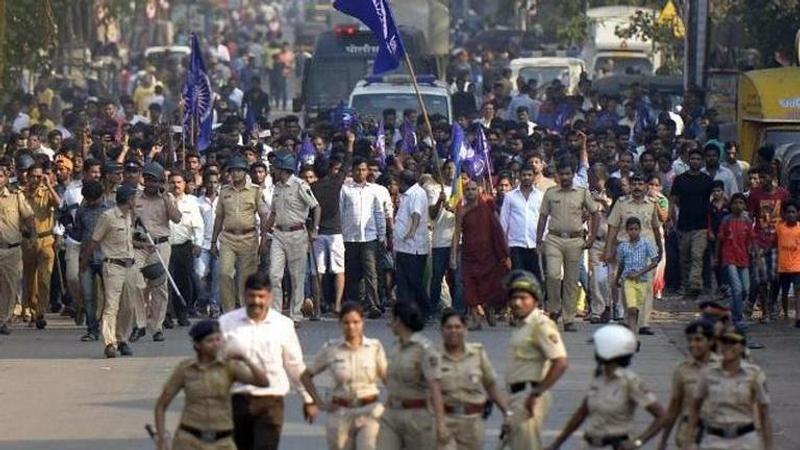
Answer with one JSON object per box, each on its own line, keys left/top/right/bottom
{"left": 183, "top": 34, "right": 214, "bottom": 152}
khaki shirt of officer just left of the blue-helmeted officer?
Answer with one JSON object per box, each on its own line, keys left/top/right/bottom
{"left": 216, "top": 183, "right": 267, "bottom": 232}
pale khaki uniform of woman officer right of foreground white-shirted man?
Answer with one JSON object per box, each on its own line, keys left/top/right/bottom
{"left": 306, "top": 338, "right": 387, "bottom": 450}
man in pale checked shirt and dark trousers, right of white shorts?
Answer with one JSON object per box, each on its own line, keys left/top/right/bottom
{"left": 339, "top": 158, "right": 386, "bottom": 319}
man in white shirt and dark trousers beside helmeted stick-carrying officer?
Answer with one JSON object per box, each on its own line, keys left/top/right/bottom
{"left": 168, "top": 171, "right": 205, "bottom": 327}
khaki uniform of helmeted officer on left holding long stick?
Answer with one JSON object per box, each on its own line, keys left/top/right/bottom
{"left": 133, "top": 192, "right": 180, "bottom": 333}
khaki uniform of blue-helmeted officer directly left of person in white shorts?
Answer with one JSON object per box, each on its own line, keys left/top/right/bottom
{"left": 269, "top": 175, "right": 319, "bottom": 321}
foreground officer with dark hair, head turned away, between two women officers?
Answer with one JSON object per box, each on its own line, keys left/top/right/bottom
{"left": 378, "top": 301, "right": 450, "bottom": 450}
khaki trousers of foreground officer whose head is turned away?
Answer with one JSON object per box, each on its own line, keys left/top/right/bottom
{"left": 378, "top": 408, "right": 436, "bottom": 450}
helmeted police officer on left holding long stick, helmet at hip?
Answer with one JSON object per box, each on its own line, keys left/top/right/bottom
{"left": 126, "top": 162, "right": 181, "bottom": 342}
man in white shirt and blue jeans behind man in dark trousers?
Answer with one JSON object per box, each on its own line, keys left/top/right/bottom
{"left": 194, "top": 173, "right": 220, "bottom": 317}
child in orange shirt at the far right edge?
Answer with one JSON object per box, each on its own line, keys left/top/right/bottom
{"left": 776, "top": 200, "right": 800, "bottom": 328}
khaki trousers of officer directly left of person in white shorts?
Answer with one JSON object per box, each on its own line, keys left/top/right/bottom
{"left": 269, "top": 230, "right": 308, "bottom": 321}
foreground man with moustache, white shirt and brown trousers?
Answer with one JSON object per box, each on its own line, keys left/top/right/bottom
{"left": 219, "top": 272, "right": 319, "bottom": 450}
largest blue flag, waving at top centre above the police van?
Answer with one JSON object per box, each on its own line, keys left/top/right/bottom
{"left": 333, "top": 0, "right": 406, "bottom": 75}
